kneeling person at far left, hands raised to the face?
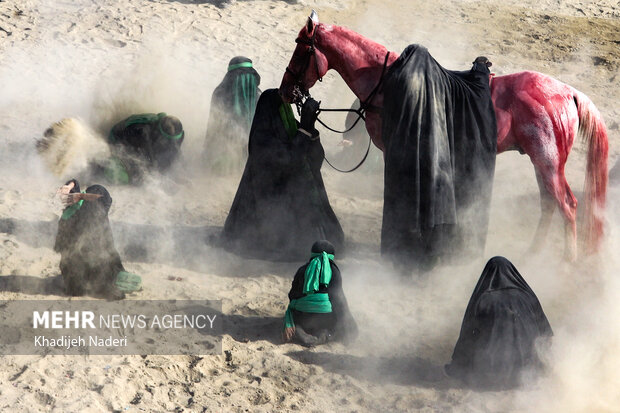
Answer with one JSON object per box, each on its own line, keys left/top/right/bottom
{"left": 54, "top": 179, "right": 141, "bottom": 299}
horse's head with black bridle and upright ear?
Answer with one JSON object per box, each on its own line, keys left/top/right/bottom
{"left": 280, "top": 10, "right": 329, "bottom": 102}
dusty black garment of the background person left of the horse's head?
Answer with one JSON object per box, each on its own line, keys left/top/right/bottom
{"left": 203, "top": 56, "right": 261, "bottom": 174}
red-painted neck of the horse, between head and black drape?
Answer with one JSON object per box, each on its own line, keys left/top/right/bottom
{"left": 317, "top": 25, "right": 398, "bottom": 104}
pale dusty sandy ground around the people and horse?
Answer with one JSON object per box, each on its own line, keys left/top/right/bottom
{"left": 0, "top": 0, "right": 620, "bottom": 412}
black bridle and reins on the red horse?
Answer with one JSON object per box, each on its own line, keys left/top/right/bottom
{"left": 286, "top": 28, "right": 390, "bottom": 173}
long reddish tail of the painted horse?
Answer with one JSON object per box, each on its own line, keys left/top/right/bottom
{"left": 574, "top": 91, "right": 609, "bottom": 254}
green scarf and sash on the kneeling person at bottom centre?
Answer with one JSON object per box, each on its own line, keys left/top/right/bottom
{"left": 284, "top": 251, "right": 334, "bottom": 328}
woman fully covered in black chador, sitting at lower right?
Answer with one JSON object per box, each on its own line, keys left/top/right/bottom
{"left": 445, "top": 257, "right": 553, "bottom": 388}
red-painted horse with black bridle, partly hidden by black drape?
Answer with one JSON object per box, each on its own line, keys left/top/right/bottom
{"left": 280, "top": 11, "right": 608, "bottom": 260}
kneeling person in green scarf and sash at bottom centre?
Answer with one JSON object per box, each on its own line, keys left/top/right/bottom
{"left": 283, "top": 240, "right": 357, "bottom": 346}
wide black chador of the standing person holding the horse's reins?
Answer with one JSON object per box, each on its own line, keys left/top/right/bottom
{"left": 223, "top": 89, "right": 344, "bottom": 261}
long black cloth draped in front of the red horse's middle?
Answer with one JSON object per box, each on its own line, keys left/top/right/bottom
{"left": 381, "top": 45, "right": 497, "bottom": 265}
